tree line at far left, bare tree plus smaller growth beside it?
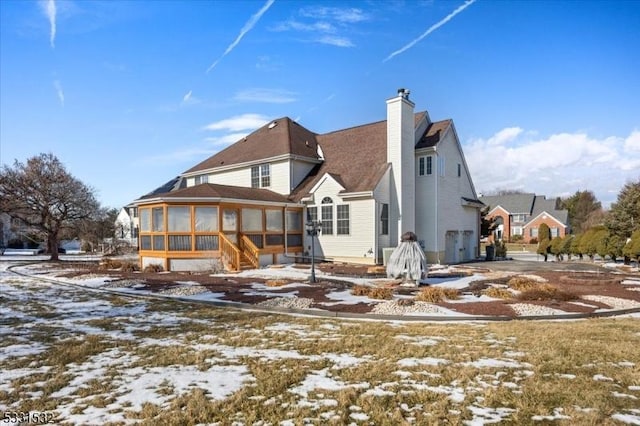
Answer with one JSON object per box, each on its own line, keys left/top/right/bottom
{"left": 0, "top": 154, "right": 127, "bottom": 260}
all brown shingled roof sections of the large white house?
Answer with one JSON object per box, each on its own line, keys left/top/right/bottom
{"left": 143, "top": 111, "right": 451, "bottom": 202}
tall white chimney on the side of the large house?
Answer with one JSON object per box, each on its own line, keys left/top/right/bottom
{"left": 387, "top": 89, "right": 416, "bottom": 242}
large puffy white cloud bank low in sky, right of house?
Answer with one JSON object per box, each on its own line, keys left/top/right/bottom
{"left": 464, "top": 127, "right": 640, "bottom": 206}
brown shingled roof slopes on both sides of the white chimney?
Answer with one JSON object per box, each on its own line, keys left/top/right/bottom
{"left": 291, "top": 112, "right": 451, "bottom": 201}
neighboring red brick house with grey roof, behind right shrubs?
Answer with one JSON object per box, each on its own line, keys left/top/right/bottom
{"left": 480, "top": 193, "right": 569, "bottom": 243}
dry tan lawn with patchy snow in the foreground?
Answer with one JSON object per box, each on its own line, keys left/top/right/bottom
{"left": 0, "top": 263, "right": 640, "bottom": 425}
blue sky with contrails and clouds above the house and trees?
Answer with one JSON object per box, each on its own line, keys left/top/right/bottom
{"left": 0, "top": 0, "right": 640, "bottom": 207}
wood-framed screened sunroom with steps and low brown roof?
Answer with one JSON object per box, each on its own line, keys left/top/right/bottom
{"left": 136, "top": 184, "right": 304, "bottom": 271}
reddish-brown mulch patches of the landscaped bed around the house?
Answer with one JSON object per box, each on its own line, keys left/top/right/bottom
{"left": 37, "top": 263, "right": 640, "bottom": 317}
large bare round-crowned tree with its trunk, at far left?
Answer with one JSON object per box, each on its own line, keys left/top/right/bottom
{"left": 0, "top": 154, "right": 99, "bottom": 260}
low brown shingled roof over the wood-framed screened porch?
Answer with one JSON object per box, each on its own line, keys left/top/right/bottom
{"left": 141, "top": 183, "right": 291, "bottom": 203}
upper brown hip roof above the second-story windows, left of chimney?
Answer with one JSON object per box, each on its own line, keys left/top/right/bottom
{"left": 185, "top": 117, "right": 318, "bottom": 173}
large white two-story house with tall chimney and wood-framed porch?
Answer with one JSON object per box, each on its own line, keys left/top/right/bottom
{"left": 133, "top": 89, "right": 483, "bottom": 270}
